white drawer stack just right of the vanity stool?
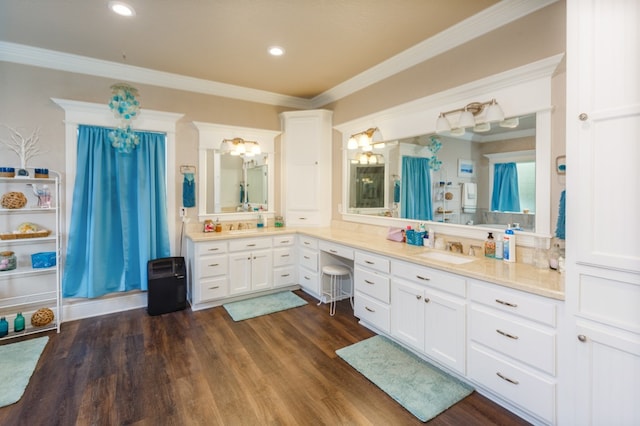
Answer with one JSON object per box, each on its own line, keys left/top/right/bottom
{"left": 353, "top": 251, "right": 391, "bottom": 334}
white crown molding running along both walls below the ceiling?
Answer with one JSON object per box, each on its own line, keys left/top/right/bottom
{"left": 0, "top": 0, "right": 557, "bottom": 109}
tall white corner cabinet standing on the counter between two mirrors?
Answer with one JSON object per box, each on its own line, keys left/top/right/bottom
{"left": 280, "top": 110, "right": 332, "bottom": 226}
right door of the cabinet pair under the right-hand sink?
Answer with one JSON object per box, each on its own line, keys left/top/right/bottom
{"left": 423, "top": 289, "right": 466, "bottom": 374}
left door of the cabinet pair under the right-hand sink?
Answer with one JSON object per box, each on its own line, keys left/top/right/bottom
{"left": 391, "top": 280, "right": 425, "bottom": 351}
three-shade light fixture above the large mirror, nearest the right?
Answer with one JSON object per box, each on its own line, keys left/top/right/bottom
{"left": 436, "top": 99, "right": 504, "bottom": 136}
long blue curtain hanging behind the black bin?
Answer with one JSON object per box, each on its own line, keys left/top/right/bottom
{"left": 62, "top": 125, "right": 170, "bottom": 298}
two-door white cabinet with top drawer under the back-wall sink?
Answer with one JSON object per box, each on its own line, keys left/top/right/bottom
{"left": 229, "top": 237, "right": 273, "bottom": 295}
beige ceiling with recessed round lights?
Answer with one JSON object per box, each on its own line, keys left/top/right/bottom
{"left": 0, "top": 0, "right": 549, "bottom": 103}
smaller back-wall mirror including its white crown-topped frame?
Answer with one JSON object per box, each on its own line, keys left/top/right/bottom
{"left": 194, "top": 122, "right": 280, "bottom": 220}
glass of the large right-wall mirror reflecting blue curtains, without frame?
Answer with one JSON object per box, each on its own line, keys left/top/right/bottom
{"left": 347, "top": 114, "right": 536, "bottom": 232}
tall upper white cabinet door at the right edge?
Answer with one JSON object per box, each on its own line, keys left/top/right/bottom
{"left": 566, "top": 0, "right": 640, "bottom": 271}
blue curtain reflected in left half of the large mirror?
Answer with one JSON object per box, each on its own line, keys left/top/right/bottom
{"left": 400, "top": 157, "right": 433, "bottom": 220}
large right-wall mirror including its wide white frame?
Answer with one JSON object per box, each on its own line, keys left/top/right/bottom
{"left": 336, "top": 55, "right": 562, "bottom": 237}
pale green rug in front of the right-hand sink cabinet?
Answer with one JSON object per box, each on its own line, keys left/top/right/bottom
{"left": 336, "top": 336, "right": 473, "bottom": 422}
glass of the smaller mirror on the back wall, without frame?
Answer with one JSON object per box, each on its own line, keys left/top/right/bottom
{"left": 206, "top": 149, "right": 269, "bottom": 214}
